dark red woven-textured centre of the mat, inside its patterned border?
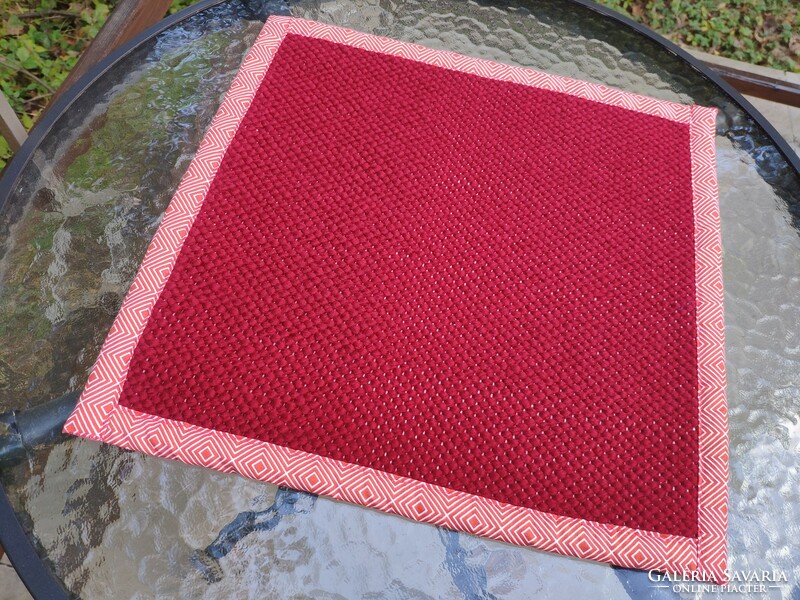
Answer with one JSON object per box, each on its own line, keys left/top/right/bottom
{"left": 120, "top": 34, "right": 698, "bottom": 537}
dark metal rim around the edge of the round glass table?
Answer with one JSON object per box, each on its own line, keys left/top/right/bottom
{"left": 0, "top": 0, "right": 800, "bottom": 600}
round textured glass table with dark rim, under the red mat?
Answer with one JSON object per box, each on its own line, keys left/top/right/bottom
{"left": 0, "top": 0, "right": 800, "bottom": 599}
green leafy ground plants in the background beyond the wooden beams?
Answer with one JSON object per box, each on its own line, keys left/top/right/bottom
{"left": 0, "top": 0, "right": 800, "bottom": 169}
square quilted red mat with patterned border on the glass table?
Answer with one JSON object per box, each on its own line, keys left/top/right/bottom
{"left": 65, "top": 17, "right": 727, "bottom": 580}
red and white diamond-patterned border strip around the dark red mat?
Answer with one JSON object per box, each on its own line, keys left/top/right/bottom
{"left": 64, "top": 16, "right": 728, "bottom": 582}
